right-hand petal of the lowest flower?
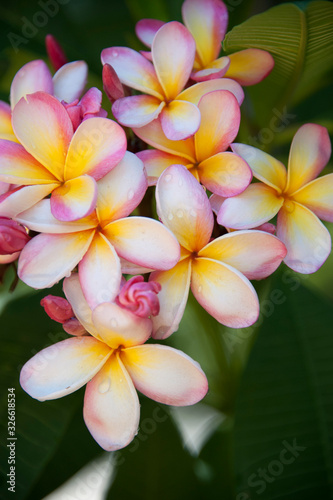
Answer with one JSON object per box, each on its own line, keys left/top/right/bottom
{"left": 122, "top": 345, "right": 208, "bottom": 406}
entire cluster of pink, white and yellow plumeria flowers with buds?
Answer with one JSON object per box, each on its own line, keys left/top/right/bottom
{"left": 0, "top": 0, "right": 333, "bottom": 450}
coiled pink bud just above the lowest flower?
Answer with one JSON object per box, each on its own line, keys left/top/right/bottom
{"left": 116, "top": 276, "right": 161, "bottom": 318}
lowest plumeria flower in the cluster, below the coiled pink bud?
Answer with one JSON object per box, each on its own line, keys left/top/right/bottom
{"left": 20, "top": 274, "right": 208, "bottom": 451}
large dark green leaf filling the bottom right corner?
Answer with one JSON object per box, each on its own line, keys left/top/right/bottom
{"left": 235, "top": 280, "right": 333, "bottom": 500}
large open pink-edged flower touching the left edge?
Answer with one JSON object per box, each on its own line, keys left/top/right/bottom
{"left": 0, "top": 92, "right": 127, "bottom": 221}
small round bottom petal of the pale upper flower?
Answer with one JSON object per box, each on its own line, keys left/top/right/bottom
{"left": 160, "top": 101, "right": 200, "bottom": 141}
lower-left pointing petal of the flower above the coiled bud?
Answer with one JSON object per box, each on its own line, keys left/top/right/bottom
{"left": 18, "top": 230, "right": 94, "bottom": 288}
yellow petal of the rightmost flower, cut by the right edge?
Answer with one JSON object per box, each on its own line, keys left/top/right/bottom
{"left": 293, "top": 174, "right": 333, "bottom": 222}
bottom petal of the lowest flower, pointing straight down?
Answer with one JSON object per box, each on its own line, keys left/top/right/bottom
{"left": 83, "top": 354, "right": 140, "bottom": 451}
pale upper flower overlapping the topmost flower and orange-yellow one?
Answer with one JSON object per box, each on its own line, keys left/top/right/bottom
{"left": 101, "top": 21, "right": 243, "bottom": 141}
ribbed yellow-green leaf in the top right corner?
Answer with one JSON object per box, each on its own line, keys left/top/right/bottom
{"left": 223, "top": 1, "right": 333, "bottom": 125}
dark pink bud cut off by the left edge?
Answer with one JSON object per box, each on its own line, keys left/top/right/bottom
{"left": 0, "top": 217, "right": 30, "bottom": 255}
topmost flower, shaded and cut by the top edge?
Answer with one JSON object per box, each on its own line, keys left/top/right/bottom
{"left": 136, "top": 0, "right": 274, "bottom": 86}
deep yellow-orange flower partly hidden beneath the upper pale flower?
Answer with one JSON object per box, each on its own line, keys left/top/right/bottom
{"left": 134, "top": 90, "right": 252, "bottom": 197}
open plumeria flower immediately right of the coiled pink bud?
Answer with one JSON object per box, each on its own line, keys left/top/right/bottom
{"left": 150, "top": 165, "right": 287, "bottom": 338}
